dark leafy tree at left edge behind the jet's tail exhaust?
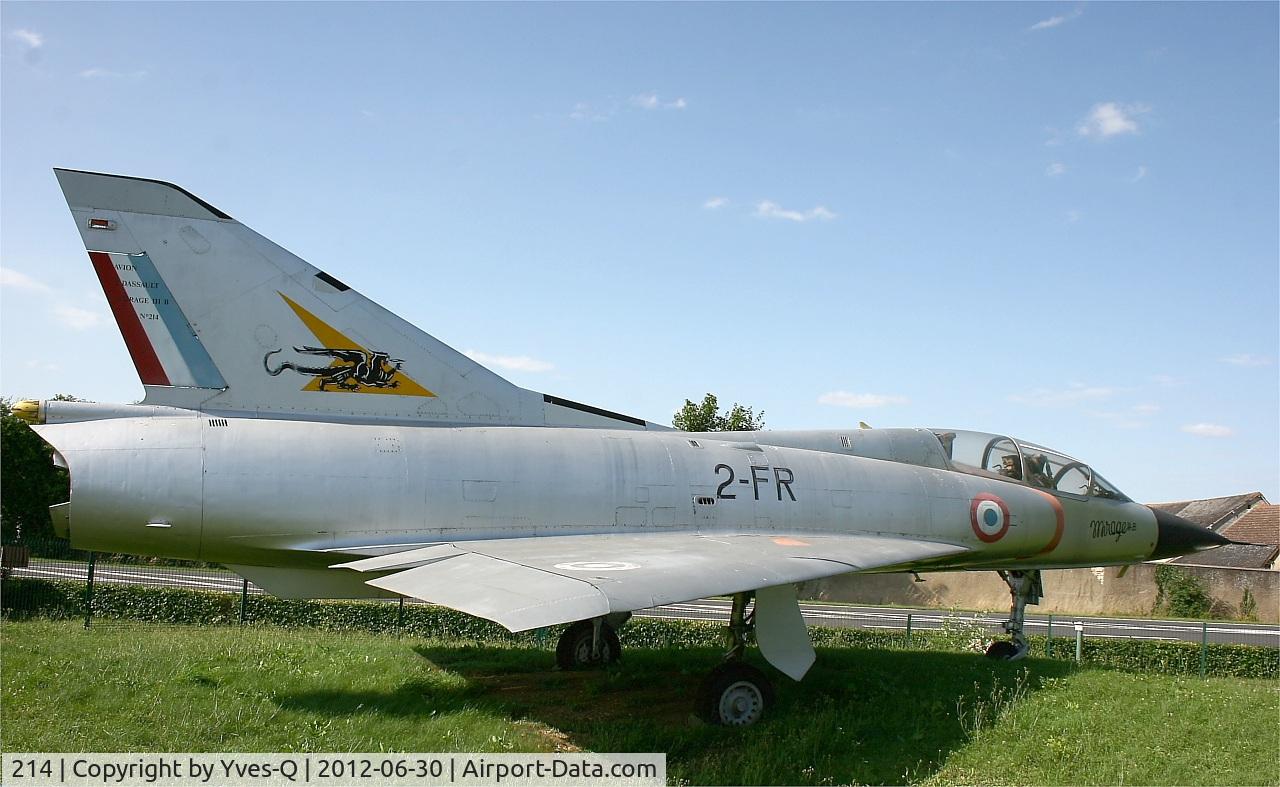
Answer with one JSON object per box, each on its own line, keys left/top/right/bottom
{"left": 0, "top": 394, "right": 74, "bottom": 544}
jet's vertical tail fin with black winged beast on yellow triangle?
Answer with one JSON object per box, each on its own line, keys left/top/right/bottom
{"left": 55, "top": 169, "right": 655, "bottom": 429}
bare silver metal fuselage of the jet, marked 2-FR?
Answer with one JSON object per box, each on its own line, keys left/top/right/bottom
{"left": 37, "top": 413, "right": 1157, "bottom": 571}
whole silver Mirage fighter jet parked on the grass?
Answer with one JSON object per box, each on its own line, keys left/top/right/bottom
{"left": 15, "top": 169, "right": 1225, "bottom": 724}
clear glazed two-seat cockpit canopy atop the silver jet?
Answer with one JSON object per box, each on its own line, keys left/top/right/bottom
{"left": 932, "top": 429, "right": 1129, "bottom": 500}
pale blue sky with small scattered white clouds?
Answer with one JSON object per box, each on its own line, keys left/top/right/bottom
{"left": 0, "top": 1, "right": 1280, "bottom": 502}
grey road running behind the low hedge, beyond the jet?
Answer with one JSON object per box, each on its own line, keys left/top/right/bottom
{"left": 13, "top": 558, "right": 1280, "bottom": 648}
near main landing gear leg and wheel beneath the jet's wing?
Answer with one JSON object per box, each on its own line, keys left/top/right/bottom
{"left": 698, "top": 592, "right": 773, "bottom": 727}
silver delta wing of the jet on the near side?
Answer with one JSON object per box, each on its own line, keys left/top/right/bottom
{"left": 333, "top": 534, "right": 968, "bottom": 631}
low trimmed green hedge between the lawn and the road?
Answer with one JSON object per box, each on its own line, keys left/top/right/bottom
{"left": 0, "top": 578, "right": 1280, "bottom": 678}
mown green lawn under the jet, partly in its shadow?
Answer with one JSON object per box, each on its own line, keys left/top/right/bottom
{"left": 0, "top": 621, "right": 1280, "bottom": 784}
